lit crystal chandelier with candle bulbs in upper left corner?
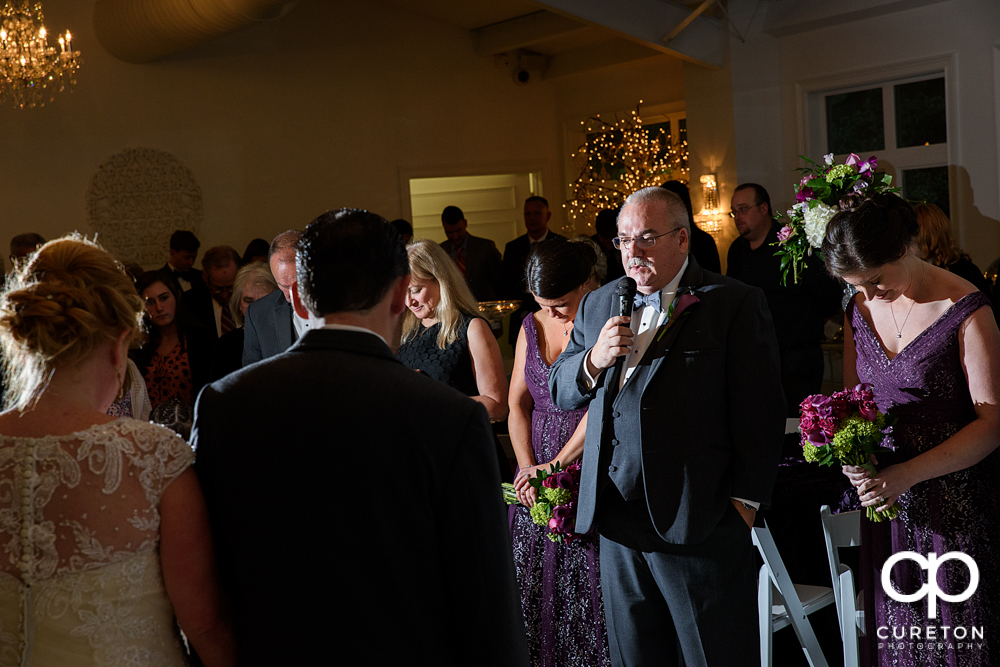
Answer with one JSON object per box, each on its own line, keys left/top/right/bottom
{"left": 0, "top": 1, "right": 80, "bottom": 109}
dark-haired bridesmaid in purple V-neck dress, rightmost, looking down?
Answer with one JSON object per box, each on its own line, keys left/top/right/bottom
{"left": 823, "top": 195, "right": 1000, "bottom": 667}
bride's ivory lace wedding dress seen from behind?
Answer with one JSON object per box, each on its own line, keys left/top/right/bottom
{"left": 0, "top": 419, "right": 194, "bottom": 667}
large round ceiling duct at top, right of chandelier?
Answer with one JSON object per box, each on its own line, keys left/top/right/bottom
{"left": 94, "top": 0, "right": 295, "bottom": 64}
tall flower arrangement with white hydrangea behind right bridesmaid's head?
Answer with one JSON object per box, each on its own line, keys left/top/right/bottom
{"left": 775, "top": 153, "right": 899, "bottom": 285}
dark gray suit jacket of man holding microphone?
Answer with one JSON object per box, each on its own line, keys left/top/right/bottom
{"left": 549, "top": 257, "right": 785, "bottom": 544}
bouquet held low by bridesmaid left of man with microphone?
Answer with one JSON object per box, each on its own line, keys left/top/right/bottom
{"left": 501, "top": 461, "right": 582, "bottom": 543}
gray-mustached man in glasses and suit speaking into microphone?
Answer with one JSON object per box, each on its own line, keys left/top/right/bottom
{"left": 549, "top": 187, "right": 785, "bottom": 667}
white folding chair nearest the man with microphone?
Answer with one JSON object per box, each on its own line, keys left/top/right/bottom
{"left": 753, "top": 521, "right": 836, "bottom": 667}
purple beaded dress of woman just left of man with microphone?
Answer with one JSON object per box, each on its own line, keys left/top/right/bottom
{"left": 509, "top": 315, "right": 611, "bottom": 667}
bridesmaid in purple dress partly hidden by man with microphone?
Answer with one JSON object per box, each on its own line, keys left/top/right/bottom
{"left": 507, "top": 240, "right": 610, "bottom": 667}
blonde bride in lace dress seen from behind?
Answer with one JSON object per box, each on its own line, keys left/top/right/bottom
{"left": 0, "top": 237, "right": 235, "bottom": 667}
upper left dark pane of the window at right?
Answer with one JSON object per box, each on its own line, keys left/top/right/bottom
{"left": 826, "top": 88, "right": 885, "bottom": 155}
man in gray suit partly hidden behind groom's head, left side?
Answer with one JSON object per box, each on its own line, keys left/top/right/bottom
{"left": 243, "top": 229, "right": 306, "bottom": 366}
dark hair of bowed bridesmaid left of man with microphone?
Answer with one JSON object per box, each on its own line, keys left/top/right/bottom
{"left": 524, "top": 238, "right": 597, "bottom": 299}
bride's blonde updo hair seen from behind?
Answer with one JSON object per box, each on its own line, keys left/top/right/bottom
{"left": 0, "top": 235, "right": 143, "bottom": 410}
